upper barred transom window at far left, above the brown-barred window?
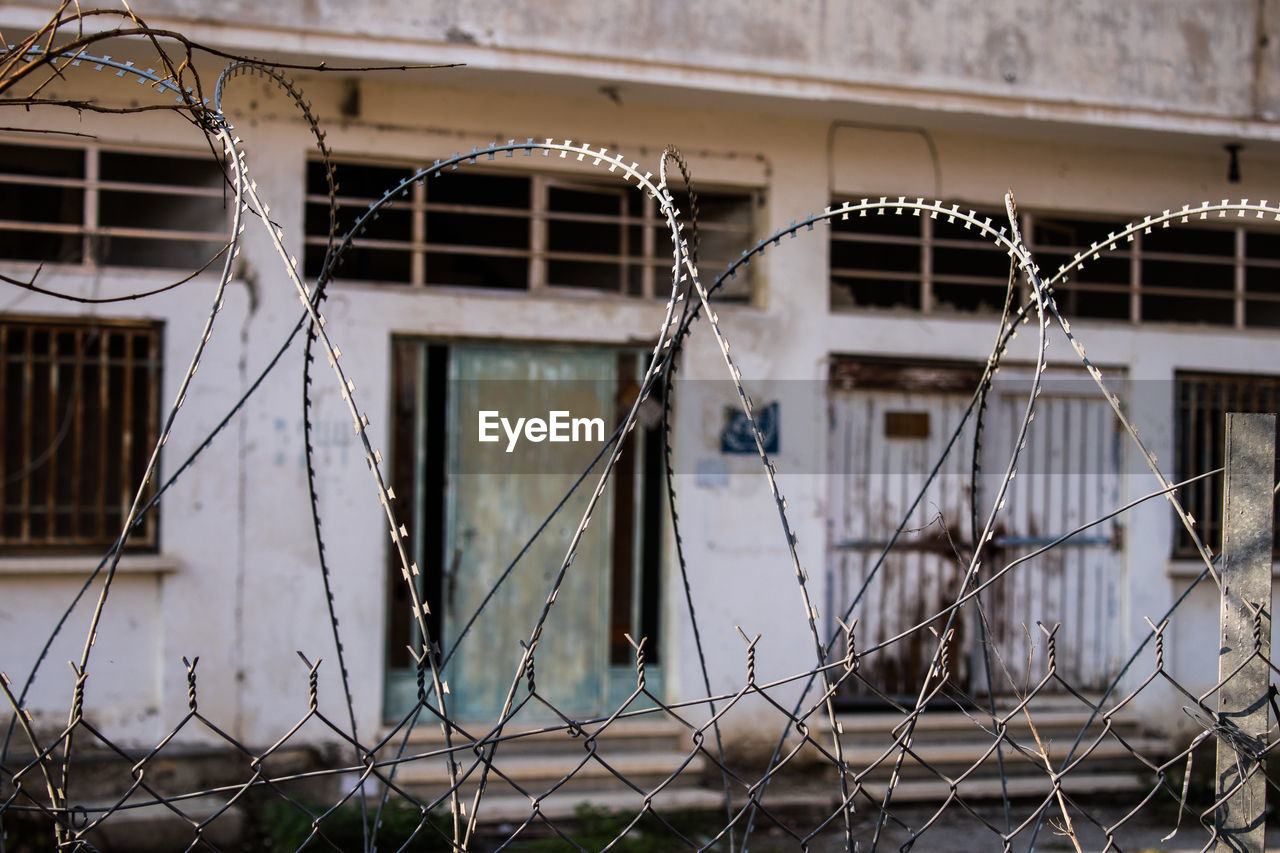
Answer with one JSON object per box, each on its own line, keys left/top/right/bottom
{"left": 0, "top": 140, "right": 228, "bottom": 270}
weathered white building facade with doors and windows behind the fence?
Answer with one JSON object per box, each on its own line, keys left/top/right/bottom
{"left": 0, "top": 0, "right": 1280, "bottom": 758}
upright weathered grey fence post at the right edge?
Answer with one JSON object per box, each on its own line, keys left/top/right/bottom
{"left": 1213, "top": 412, "right": 1276, "bottom": 853}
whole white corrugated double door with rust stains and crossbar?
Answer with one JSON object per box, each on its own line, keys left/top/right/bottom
{"left": 829, "top": 361, "right": 1124, "bottom": 703}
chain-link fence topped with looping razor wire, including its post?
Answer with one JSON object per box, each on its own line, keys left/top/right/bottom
{"left": 0, "top": 6, "right": 1280, "bottom": 850}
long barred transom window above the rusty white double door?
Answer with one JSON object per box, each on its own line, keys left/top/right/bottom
{"left": 829, "top": 204, "right": 1280, "bottom": 328}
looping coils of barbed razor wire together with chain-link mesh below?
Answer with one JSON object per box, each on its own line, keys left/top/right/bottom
{"left": 0, "top": 16, "right": 1280, "bottom": 849}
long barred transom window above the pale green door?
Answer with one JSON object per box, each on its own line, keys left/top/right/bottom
{"left": 305, "top": 161, "right": 755, "bottom": 302}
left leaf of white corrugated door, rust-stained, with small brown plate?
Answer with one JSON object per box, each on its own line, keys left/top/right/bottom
{"left": 829, "top": 360, "right": 980, "bottom": 702}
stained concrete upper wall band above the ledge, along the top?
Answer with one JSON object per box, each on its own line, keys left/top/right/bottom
{"left": 94, "top": 0, "right": 1280, "bottom": 118}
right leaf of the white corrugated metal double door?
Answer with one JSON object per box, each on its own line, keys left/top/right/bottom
{"left": 983, "top": 369, "right": 1125, "bottom": 693}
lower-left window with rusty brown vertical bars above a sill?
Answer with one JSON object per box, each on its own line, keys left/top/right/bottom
{"left": 0, "top": 318, "right": 161, "bottom": 553}
